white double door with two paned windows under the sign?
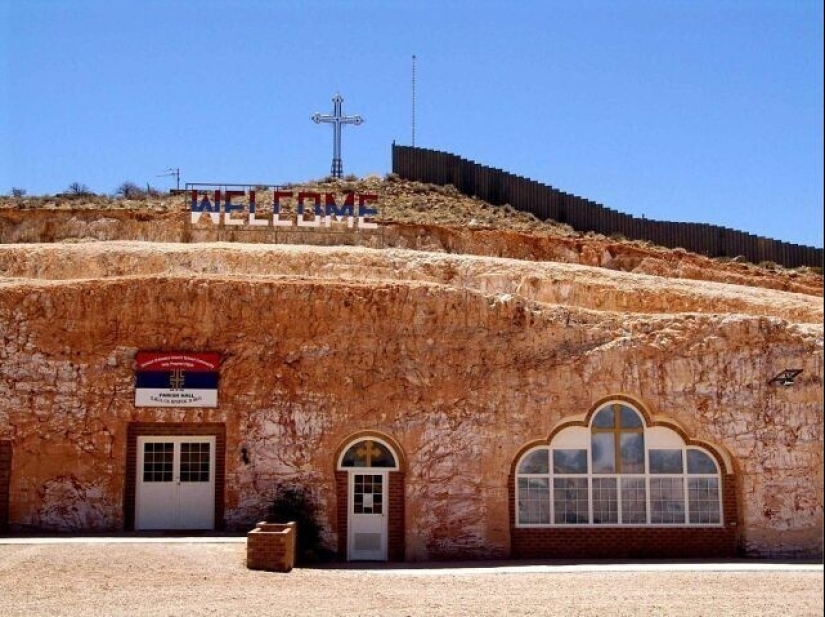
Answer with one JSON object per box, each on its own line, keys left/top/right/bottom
{"left": 135, "top": 436, "right": 215, "bottom": 529}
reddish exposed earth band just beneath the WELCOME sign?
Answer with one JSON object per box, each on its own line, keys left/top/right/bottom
{"left": 0, "top": 205, "right": 823, "bottom": 297}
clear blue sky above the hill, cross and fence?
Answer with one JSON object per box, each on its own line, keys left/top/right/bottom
{"left": 0, "top": 0, "right": 823, "bottom": 247}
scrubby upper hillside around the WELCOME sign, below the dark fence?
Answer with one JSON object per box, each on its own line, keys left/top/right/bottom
{"left": 0, "top": 178, "right": 823, "bottom": 296}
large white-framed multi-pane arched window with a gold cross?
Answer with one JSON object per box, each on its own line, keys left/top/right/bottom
{"left": 516, "top": 402, "right": 722, "bottom": 527}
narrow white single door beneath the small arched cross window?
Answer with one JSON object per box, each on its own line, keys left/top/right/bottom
{"left": 348, "top": 471, "right": 388, "bottom": 561}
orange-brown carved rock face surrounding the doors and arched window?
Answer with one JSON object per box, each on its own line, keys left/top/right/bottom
{"left": 0, "top": 243, "right": 823, "bottom": 559}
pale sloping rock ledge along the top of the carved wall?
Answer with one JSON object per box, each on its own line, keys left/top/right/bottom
{"left": 0, "top": 242, "right": 823, "bottom": 324}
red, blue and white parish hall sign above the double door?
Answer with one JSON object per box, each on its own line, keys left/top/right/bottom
{"left": 135, "top": 351, "right": 220, "bottom": 407}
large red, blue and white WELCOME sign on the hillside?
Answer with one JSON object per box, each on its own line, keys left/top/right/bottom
{"left": 189, "top": 188, "right": 378, "bottom": 229}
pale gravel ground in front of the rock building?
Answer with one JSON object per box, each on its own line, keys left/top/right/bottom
{"left": 0, "top": 542, "right": 823, "bottom": 617}
